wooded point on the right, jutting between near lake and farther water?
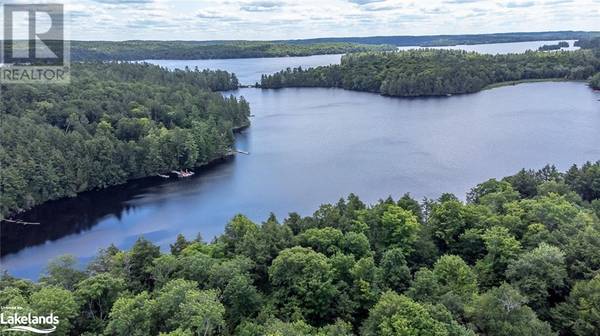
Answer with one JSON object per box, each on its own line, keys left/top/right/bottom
{"left": 260, "top": 49, "right": 600, "bottom": 97}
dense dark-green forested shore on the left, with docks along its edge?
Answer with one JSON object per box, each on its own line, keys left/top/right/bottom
{"left": 0, "top": 63, "right": 249, "bottom": 217}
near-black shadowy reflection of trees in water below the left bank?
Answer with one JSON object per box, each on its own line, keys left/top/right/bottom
{"left": 0, "top": 159, "right": 231, "bottom": 256}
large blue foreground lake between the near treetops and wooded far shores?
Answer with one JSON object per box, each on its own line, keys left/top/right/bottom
{"left": 1, "top": 44, "right": 600, "bottom": 279}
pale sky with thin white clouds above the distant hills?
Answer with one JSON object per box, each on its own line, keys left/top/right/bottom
{"left": 0, "top": 0, "right": 600, "bottom": 40}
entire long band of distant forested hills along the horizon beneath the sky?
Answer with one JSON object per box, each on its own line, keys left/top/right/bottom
{"left": 9, "top": 31, "right": 600, "bottom": 61}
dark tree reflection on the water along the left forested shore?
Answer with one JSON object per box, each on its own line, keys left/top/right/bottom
{"left": 0, "top": 158, "right": 236, "bottom": 256}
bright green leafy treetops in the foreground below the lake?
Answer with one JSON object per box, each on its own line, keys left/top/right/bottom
{"left": 0, "top": 161, "right": 600, "bottom": 336}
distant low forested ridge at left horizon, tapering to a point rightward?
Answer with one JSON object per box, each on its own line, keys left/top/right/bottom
{"left": 71, "top": 41, "right": 395, "bottom": 61}
